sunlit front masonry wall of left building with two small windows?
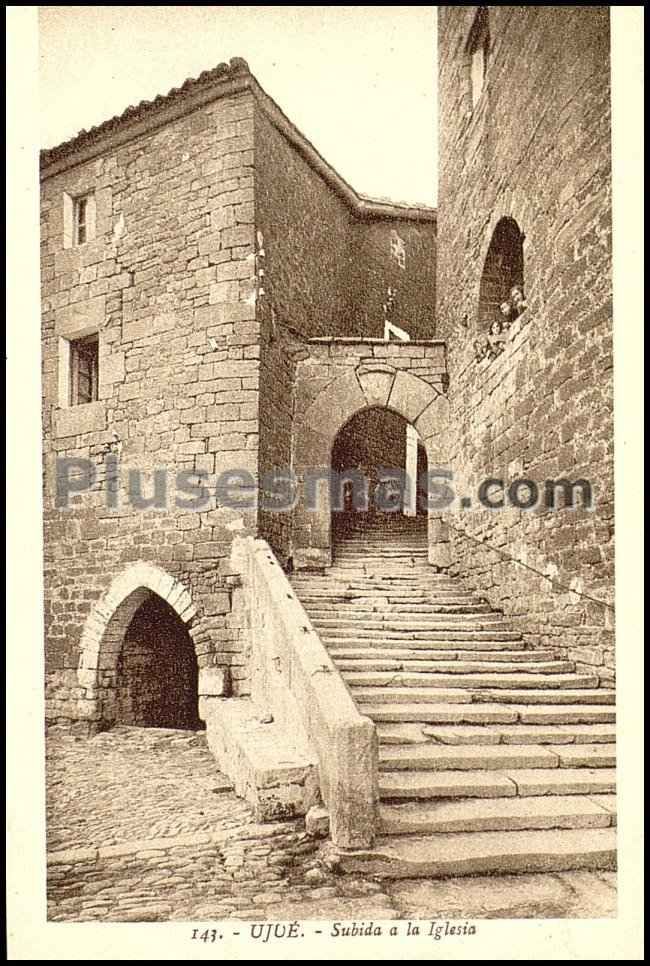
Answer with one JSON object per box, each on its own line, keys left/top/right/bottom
{"left": 42, "top": 94, "right": 259, "bottom": 721}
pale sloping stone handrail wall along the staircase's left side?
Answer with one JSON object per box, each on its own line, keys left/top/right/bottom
{"left": 232, "top": 537, "right": 377, "bottom": 848}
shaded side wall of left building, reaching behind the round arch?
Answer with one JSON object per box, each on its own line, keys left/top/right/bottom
{"left": 255, "top": 108, "right": 435, "bottom": 562}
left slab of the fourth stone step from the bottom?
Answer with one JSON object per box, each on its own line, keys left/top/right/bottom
{"left": 379, "top": 744, "right": 560, "bottom": 771}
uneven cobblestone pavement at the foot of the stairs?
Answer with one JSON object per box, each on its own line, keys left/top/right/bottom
{"left": 47, "top": 728, "right": 616, "bottom": 922}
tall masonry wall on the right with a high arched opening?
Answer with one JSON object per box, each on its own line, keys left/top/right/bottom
{"left": 437, "top": 6, "right": 614, "bottom": 682}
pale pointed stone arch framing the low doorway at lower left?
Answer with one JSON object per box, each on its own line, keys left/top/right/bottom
{"left": 77, "top": 561, "right": 196, "bottom": 726}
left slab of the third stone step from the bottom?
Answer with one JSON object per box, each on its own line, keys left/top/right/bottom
{"left": 379, "top": 769, "right": 512, "bottom": 799}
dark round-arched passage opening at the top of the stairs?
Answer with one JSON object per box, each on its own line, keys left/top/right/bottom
{"left": 331, "top": 406, "right": 427, "bottom": 543}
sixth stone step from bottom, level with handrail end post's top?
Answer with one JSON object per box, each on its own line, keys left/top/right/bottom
{"left": 359, "top": 702, "right": 616, "bottom": 726}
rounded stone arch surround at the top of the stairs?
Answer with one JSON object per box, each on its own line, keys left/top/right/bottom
{"left": 293, "top": 362, "right": 449, "bottom": 569}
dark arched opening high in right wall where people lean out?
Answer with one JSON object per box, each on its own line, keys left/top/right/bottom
{"left": 478, "top": 218, "right": 524, "bottom": 331}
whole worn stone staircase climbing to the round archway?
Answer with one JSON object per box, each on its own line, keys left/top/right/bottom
{"left": 292, "top": 517, "right": 616, "bottom": 877}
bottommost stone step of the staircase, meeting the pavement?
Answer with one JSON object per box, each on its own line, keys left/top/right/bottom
{"left": 339, "top": 828, "right": 616, "bottom": 879}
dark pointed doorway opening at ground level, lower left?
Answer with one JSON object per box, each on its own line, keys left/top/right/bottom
{"left": 114, "top": 593, "right": 204, "bottom": 730}
